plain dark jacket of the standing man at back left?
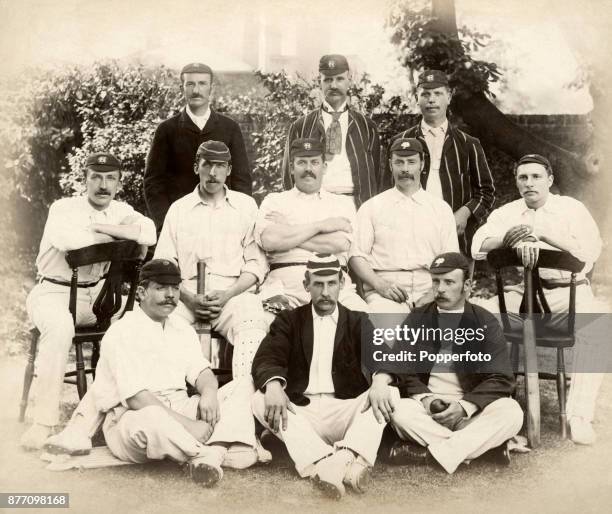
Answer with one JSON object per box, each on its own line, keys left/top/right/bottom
{"left": 144, "top": 108, "right": 253, "bottom": 231}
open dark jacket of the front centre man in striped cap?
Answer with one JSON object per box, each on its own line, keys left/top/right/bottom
{"left": 252, "top": 303, "right": 384, "bottom": 405}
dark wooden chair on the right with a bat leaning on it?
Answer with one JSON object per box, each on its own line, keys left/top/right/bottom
{"left": 487, "top": 248, "right": 584, "bottom": 439}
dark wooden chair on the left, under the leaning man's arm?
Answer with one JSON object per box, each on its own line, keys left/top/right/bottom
{"left": 19, "top": 241, "right": 144, "bottom": 421}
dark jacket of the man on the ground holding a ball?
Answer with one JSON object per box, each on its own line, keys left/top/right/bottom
{"left": 401, "top": 302, "right": 516, "bottom": 409}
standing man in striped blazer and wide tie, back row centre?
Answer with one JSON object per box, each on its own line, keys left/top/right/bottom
{"left": 282, "top": 55, "right": 382, "bottom": 207}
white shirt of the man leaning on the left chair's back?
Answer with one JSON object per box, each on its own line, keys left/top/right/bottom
{"left": 36, "top": 196, "right": 157, "bottom": 283}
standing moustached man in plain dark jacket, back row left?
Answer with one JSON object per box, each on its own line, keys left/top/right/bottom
{"left": 144, "top": 63, "right": 252, "bottom": 231}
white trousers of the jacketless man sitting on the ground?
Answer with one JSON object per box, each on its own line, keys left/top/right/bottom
{"left": 103, "top": 378, "right": 256, "bottom": 463}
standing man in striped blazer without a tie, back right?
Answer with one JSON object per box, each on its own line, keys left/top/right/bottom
{"left": 395, "top": 70, "right": 495, "bottom": 255}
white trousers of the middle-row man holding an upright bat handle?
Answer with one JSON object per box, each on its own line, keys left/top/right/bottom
{"left": 171, "top": 279, "right": 267, "bottom": 378}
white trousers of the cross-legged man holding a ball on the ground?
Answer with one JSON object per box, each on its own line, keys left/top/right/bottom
{"left": 391, "top": 398, "right": 523, "bottom": 473}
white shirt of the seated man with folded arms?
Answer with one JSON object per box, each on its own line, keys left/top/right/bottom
{"left": 255, "top": 187, "right": 357, "bottom": 265}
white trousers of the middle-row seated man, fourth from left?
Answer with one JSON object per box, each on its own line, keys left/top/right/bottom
{"left": 364, "top": 270, "right": 431, "bottom": 314}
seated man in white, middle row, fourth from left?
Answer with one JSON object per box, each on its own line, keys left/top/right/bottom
{"left": 350, "top": 138, "right": 459, "bottom": 313}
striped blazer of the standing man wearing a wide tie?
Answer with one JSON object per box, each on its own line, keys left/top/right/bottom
{"left": 282, "top": 108, "right": 384, "bottom": 208}
